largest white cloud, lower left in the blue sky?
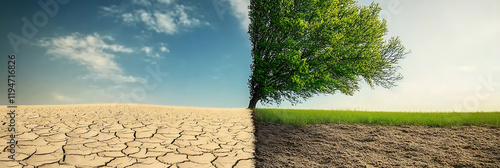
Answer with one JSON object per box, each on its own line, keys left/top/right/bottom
{"left": 39, "top": 33, "right": 143, "bottom": 83}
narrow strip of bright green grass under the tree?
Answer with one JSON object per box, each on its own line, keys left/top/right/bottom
{"left": 254, "top": 109, "right": 500, "bottom": 127}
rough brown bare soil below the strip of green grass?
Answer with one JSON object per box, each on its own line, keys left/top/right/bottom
{"left": 255, "top": 122, "right": 500, "bottom": 167}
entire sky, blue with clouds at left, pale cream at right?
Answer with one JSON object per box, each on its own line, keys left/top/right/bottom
{"left": 0, "top": 0, "right": 500, "bottom": 111}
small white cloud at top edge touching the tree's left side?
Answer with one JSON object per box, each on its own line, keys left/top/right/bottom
{"left": 227, "top": 0, "right": 250, "bottom": 30}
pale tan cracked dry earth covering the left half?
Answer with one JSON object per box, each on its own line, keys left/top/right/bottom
{"left": 0, "top": 104, "right": 254, "bottom": 168}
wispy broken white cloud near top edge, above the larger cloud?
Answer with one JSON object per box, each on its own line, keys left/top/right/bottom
{"left": 101, "top": 0, "right": 208, "bottom": 35}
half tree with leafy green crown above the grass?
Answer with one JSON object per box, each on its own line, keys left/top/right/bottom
{"left": 248, "top": 0, "right": 408, "bottom": 109}
